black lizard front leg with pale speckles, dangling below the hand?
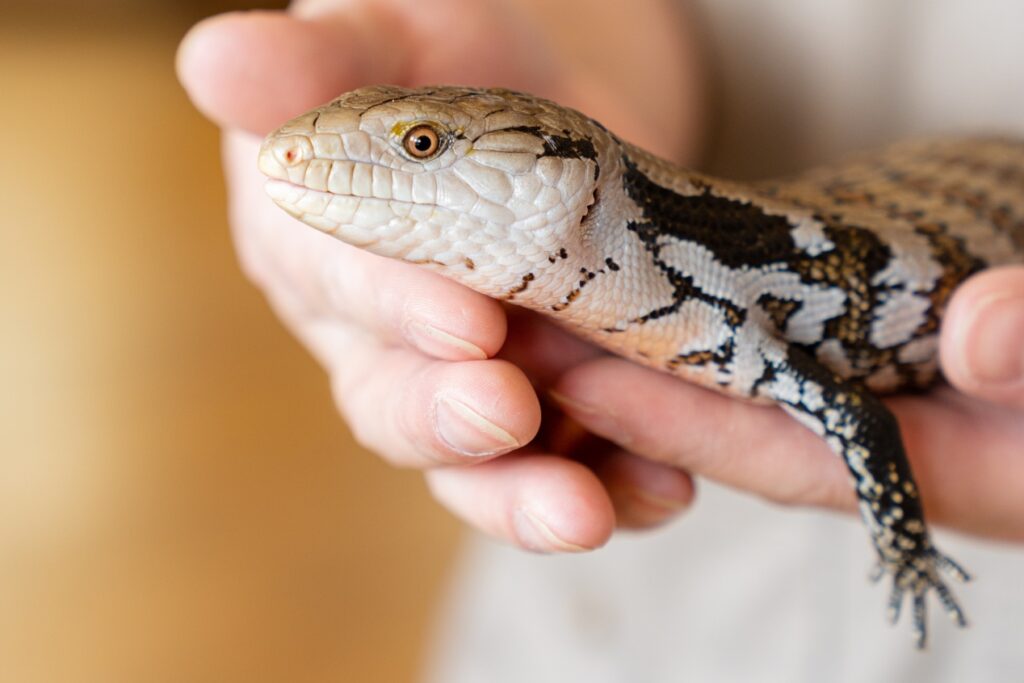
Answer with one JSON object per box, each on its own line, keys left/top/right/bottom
{"left": 754, "top": 337, "right": 969, "bottom": 647}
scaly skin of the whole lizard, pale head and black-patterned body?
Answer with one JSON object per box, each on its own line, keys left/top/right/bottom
{"left": 253, "top": 87, "right": 1024, "bottom": 646}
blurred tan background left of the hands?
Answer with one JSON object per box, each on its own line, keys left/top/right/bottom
{"left": 0, "top": 0, "right": 458, "bottom": 683}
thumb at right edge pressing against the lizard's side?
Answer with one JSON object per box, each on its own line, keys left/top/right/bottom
{"left": 940, "top": 265, "right": 1024, "bottom": 408}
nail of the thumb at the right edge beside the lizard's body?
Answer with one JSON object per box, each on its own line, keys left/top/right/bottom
{"left": 961, "top": 295, "right": 1024, "bottom": 384}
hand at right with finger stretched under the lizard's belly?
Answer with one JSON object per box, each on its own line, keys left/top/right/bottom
{"left": 554, "top": 266, "right": 1024, "bottom": 541}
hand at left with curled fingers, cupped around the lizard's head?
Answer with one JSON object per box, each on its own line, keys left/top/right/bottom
{"left": 178, "top": 0, "right": 699, "bottom": 551}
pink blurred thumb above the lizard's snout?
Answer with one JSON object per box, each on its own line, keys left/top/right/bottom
{"left": 177, "top": 8, "right": 407, "bottom": 135}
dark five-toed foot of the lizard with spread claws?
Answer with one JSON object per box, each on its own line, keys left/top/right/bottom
{"left": 871, "top": 547, "right": 971, "bottom": 649}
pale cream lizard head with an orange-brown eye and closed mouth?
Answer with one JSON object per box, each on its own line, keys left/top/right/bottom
{"left": 259, "top": 86, "right": 617, "bottom": 298}
